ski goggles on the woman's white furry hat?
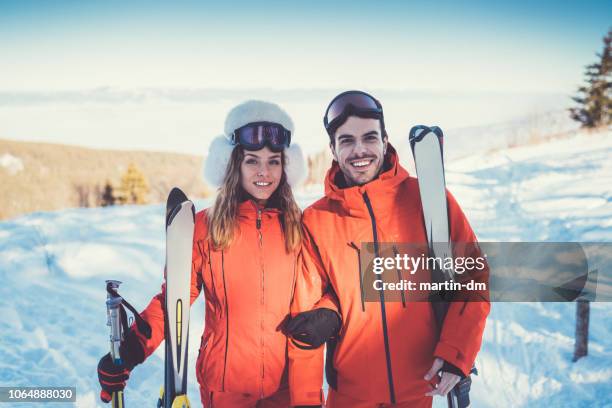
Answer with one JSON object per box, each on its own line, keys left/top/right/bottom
{"left": 232, "top": 122, "right": 291, "bottom": 152}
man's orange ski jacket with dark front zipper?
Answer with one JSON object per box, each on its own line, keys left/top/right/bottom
{"left": 288, "top": 145, "right": 490, "bottom": 405}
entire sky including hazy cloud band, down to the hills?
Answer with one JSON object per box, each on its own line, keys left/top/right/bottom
{"left": 0, "top": 0, "right": 612, "bottom": 153}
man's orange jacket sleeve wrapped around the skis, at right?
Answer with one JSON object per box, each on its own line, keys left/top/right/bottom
{"left": 434, "top": 193, "right": 491, "bottom": 375}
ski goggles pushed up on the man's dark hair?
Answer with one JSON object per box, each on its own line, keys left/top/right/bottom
{"left": 323, "top": 91, "right": 382, "bottom": 131}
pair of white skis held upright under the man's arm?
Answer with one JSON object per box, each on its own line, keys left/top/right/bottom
{"left": 409, "top": 125, "right": 477, "bottom": 408}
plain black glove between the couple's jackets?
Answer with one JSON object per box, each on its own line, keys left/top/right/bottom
{"left": 285, "top": 307, "right": 342, "bottom": 347}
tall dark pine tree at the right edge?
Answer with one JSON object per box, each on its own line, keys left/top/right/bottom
{"left": 570, "top": 29, "right": 612, "bottom": 128}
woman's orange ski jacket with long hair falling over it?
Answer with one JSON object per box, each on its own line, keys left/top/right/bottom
{"left": 134, "top": 200, "right": 298, "bottom": 398}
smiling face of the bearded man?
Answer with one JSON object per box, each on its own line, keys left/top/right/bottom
{"left": 330, "top": 116, "right": 387, "bottom": 187}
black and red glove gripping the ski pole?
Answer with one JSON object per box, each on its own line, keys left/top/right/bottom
{"left": 98, "top": 331, "right": 144, "bottom": 403}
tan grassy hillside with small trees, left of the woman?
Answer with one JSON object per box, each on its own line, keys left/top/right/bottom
{"left": 0, "top": 139, "right": 210, "bottom": 219}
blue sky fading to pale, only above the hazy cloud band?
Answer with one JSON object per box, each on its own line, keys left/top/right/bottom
{"left": 0, "top": 0, "right": 612, "bottom": 93}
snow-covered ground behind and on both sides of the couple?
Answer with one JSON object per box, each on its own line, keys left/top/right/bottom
{"left": 0, "top": 131, "right": 612, "bottom": 407}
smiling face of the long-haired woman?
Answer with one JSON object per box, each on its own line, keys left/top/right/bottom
{"left": 240, "top": 146, "right": 283, "bottom": 205}
